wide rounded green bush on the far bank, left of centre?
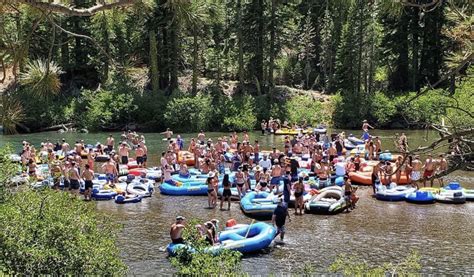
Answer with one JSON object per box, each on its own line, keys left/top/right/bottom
{"left": 164, "top": 94, "right": 213, "bottom": 132}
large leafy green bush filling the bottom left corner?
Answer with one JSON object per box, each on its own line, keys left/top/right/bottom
{"left": 0, "top": 189, "right": 126, "bottom": 275}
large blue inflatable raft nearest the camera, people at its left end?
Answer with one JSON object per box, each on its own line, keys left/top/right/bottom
{"left": 166, "top": 222, "right": 277, "bottom": 256}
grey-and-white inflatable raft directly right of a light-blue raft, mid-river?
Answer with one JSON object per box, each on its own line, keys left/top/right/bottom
{"left": 304, "top": 186, "right": 350, "bottom": 214}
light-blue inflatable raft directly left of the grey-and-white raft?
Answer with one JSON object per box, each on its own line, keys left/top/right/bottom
{"left": 240, "top": 191, "right": 278, "bottom": 219}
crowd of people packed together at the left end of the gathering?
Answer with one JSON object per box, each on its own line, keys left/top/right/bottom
{"left": 20, "top": 131, "right": 148, "bottom": 200}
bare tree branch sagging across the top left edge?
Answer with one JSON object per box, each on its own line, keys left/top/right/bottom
{"left": 9, "top": 0, "right": 141, "bottom": 16}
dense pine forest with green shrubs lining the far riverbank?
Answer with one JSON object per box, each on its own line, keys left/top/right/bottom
{"left": 0, "top": 0, "right": 474, "bottom": 133}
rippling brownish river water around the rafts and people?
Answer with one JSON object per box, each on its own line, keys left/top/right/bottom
{"left": 0, "top": 130, "right": 474, "bottom": 275}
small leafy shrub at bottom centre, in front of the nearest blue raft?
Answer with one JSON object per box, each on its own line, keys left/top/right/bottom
{"left": 170, "top": 219, "right": 242, "bottom": 276}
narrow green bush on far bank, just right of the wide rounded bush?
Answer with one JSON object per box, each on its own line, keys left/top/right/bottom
{"left": 220, "top": 94, "right": 257, "bottom": 131}
